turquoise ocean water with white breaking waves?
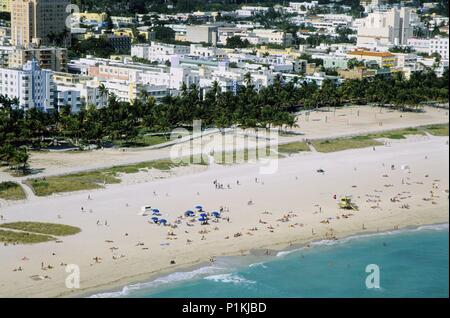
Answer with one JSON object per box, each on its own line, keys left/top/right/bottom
{"left": 94, "top": 224, "right": 449, "bottom": 298}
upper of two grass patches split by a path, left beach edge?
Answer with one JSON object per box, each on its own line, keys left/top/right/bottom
{"left": 0, "top": 222, "right": 81, "bottom": 236}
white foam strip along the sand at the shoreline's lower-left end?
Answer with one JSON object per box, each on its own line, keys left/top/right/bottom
{"left": 90, "top": 266, "right": 224, "bottom": 298}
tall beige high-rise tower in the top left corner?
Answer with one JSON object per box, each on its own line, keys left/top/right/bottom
{"left": 11, "top": 0, "right": 70, "bottom": 47}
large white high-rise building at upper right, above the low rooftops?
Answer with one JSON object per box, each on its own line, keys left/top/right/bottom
{"left": 357, "top": 7, "right": 413, "bottom": 46}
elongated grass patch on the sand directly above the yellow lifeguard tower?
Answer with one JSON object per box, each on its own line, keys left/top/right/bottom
{"left": 312, "top": 136, "right": 382, "bottom": 152}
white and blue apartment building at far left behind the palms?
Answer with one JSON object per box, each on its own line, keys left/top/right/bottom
{"left": 0, "top": 60, "right": 54, "bottom": 111}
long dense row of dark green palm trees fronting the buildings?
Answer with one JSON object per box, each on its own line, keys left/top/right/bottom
{"left": 0, "top": 71, "right": 448, "bottom": 152}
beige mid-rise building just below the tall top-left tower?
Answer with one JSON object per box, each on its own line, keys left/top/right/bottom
{"left": 8, "top": 47, "right": 67, "bottom": 72}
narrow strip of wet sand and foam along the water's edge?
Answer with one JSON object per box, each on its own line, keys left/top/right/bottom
{"left": 81, "top": 222, "right": 449, "bottom": 298}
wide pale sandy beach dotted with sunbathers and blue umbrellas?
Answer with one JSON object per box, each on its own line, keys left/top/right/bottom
{"left": 0, "top": 129, "right": 449, "bottom": 297}
